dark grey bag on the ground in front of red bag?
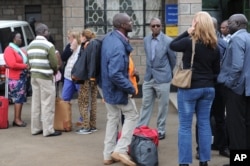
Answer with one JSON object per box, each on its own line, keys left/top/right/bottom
{"left": 129, "top": 135, "right": 158, "bottom": 166}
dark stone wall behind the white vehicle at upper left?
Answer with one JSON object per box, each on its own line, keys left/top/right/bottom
{"left": 0, "top": 0, "right": 63, "bottom": 50}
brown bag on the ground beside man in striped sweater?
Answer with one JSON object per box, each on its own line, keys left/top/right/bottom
{"left": 54, "top": 97, "right": 72, "bottom": 131}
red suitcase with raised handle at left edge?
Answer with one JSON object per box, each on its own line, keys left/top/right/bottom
{"left": 0, "top": 69, "right": 9, "bottom": 129}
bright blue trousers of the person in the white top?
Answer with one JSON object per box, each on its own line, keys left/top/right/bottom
{"left": 62, "top": 78, "right": 80, "bottom": 101}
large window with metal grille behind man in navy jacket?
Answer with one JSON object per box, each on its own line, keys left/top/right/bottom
{"left": 85, "top": 0, "right": 165, "bottom": 38}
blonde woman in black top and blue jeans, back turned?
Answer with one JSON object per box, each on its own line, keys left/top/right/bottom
{"left": 170, "top": 11, "right": 220, "bottom": 166}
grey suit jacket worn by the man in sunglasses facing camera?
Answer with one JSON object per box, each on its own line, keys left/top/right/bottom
{"left": 144, "top": 32, "right": 176, "bottom": 83}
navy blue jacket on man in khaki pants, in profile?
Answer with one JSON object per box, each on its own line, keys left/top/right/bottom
{"left": 101, "top": 30, "right": 135, "bottom": 104}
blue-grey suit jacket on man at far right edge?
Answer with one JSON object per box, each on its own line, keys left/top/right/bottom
{"left": 217, "top": 29, "right": 250, "bottom": 96}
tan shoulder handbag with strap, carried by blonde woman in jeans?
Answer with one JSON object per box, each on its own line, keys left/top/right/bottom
{"left": 172, "top": 39, "right": 195, "bottom": 88}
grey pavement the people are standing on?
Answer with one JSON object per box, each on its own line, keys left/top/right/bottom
{"left": 0, "top": 93, "right": 229, "bottom": 166}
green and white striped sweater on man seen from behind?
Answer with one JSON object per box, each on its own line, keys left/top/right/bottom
{"left": 27, "top": 36, "right": 57, "bottom": 79}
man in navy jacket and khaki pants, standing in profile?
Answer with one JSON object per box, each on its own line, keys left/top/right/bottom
{"left": 101, "top": 13, "right": 139, "bottom": 166}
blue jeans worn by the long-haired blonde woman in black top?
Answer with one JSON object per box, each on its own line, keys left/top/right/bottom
{"left": 177, "top": 87, "right": 215, "bottom": 164}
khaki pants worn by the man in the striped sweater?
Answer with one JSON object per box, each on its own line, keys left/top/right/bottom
{"left": 31, "top": 78, "right": 56, "bottom": 136}
